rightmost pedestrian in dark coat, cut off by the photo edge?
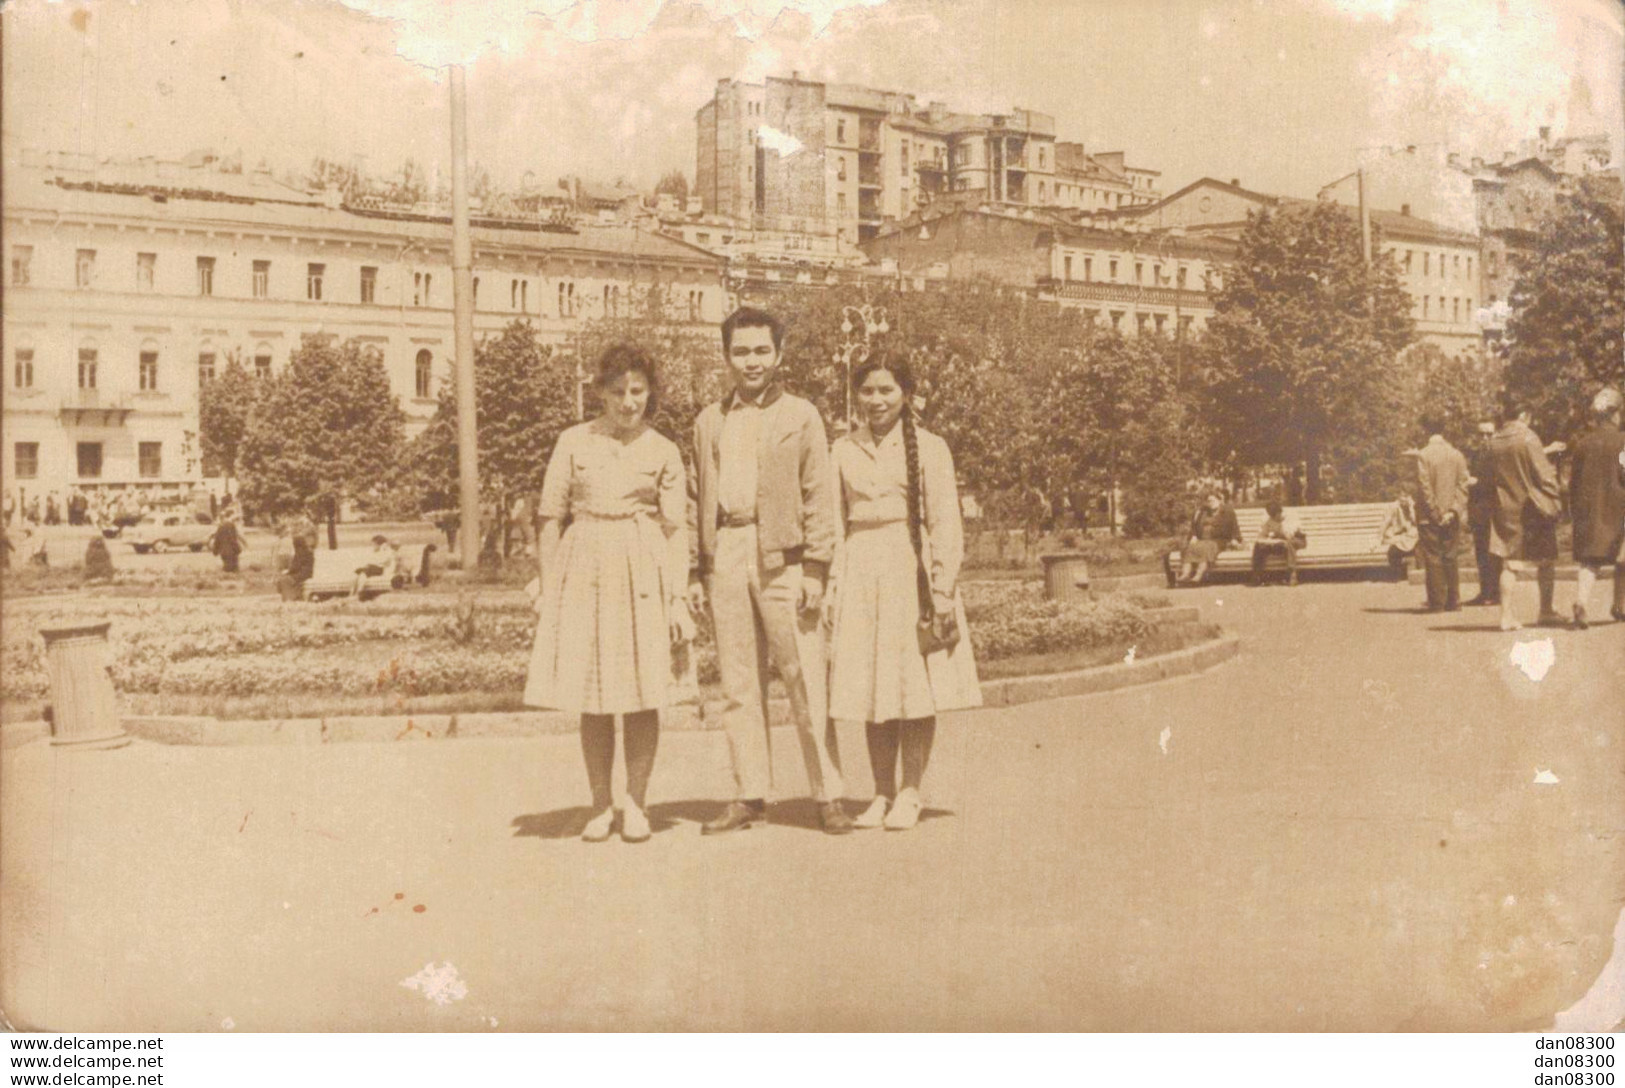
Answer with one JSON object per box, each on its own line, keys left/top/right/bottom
{"left": 1568, "top": 388, "right": 1625, "bottom": 630}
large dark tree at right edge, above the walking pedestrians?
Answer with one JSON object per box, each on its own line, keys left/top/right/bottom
{"left": 1506, "top": 179, "right": 1625, "bottom": 437}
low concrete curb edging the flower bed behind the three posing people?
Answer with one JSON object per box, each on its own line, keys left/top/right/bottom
{"left": 0, "top": 630, "right": 1242, "bottom": 749}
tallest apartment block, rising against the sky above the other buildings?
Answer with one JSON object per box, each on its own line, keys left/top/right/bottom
{"left": 696, "top": 75, "right": 1157, "bottom": 242}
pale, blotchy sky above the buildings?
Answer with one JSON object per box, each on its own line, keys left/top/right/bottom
{"left": 0, "top": 0, "right": 1625, "bottom": 207}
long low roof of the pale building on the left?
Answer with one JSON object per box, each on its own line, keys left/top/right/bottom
{"left": 5, "top": 169, "right": 722, "bottom": 266}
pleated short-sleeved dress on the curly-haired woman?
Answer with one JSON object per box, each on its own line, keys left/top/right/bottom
{"left": 525, "top": 421, "right": 697, "bottom": 715}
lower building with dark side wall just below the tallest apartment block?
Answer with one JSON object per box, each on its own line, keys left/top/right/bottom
{"left": 863, "top": 205, "right": 1235, "bottom": 336}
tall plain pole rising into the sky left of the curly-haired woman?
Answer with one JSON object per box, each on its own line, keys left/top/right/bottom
{"left": 452, "top": 65, "right": 479, "bottom": 572}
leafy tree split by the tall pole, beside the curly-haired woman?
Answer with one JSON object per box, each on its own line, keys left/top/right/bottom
{"left": 403, "top": 322, "right": 575, "bottom": 555}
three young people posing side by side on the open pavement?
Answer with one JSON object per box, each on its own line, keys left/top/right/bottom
{"left": 525, "top": 309, "right": 982, "bottom": 843}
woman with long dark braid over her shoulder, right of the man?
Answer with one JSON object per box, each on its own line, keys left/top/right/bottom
{"left": 829, "top": 356, "right": 982, "bottom": 831}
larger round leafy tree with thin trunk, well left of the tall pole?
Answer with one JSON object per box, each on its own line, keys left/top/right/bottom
{"left": 241, "top": 336, "right": 405, "bottom": 547}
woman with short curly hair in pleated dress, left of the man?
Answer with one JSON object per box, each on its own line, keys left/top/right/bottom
{"left": 525, "top": 344, "right": 697, "bottom": 843}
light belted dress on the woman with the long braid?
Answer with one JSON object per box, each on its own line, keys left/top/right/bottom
{"left": 829, "top": 427, "right": 982, "bottom": 721}
